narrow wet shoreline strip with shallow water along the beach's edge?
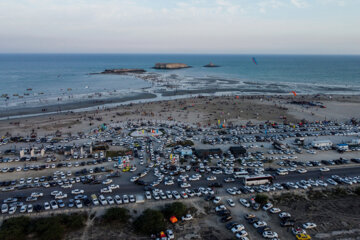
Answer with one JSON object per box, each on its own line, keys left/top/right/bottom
{"left": 0, "top": 91, "right": 360, "bottom": 121}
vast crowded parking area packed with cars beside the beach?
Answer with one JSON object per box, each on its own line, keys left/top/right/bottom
{"left": 0, "top": 121, "right": 360, "bottom": 239}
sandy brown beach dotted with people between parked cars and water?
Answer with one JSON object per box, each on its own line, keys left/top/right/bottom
{"left": 0, "top": 94, "right": 360, "bottom": 136}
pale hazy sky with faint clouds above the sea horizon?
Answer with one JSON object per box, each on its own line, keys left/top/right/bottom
{"left": 0, "top": 0, "right": 360, "bottom": 54}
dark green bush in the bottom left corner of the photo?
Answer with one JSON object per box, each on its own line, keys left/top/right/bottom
{"left": 0, "top": 217, "right": 31, "bottom": 240}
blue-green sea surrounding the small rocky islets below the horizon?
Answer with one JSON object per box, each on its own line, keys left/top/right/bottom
{"left": 0, "top": 54, "right": 360, "bottom": 114}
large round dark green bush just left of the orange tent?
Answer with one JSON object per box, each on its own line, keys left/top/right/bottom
{"left": 134, "top": 209, "right": 166, "bottom": 235}
